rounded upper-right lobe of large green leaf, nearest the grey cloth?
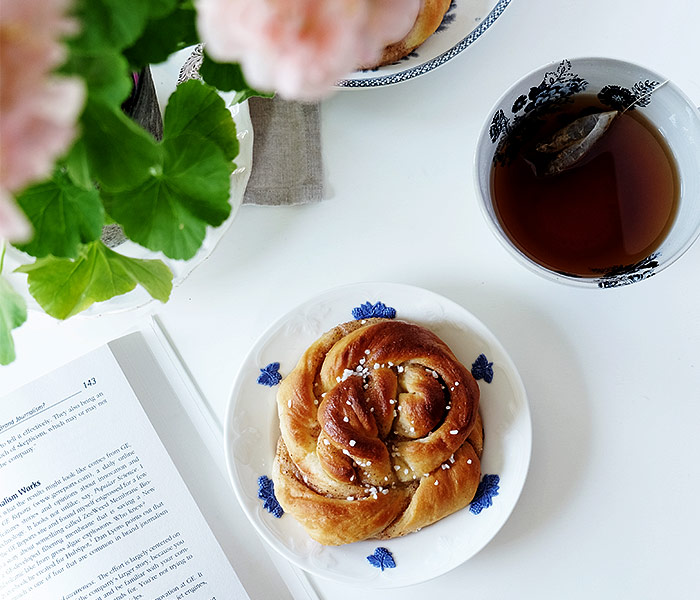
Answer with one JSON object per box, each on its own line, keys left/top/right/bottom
{"left": 163, "top": 79, "right": 238, "bottom": 160}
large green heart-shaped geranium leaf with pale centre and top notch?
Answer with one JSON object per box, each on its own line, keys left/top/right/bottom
{"left": 83, "top": 81, "right": 238, "bottom": 259}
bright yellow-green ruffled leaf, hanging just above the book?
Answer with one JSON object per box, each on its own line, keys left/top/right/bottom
{"left": 16, "top": 241, "right": 173, "bottom": 319}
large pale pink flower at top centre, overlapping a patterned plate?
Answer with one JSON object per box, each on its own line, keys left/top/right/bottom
{"left": 197, "top": 0, "right": 420, "bottom": 100}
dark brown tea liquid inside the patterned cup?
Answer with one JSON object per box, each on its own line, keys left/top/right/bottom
{"left": 491, "top": 94, "right": 680, "bottom": 277}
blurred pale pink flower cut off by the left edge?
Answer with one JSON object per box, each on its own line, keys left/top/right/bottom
{"left": 0, "top": 0, "right": 85, "bottom": 241}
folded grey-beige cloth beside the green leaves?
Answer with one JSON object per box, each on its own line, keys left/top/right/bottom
{"left": 243, "top": 97, "right": 323, "bottom": 205}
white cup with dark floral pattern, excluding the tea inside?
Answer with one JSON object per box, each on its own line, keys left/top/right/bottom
{"left": 475, "top": 58, "right": 700, "bottom": 288}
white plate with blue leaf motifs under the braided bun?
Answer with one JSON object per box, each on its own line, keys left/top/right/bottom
{"left": 224, "top": 283, "right": 531, "bottom": 588}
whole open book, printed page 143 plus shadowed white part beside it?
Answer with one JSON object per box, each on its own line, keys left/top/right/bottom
{"left": 0, "top": 322, "right": 312, "bottom": 600}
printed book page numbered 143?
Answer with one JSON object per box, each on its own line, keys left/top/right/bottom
{"left": 0, "top": 346, "right": 248, "bottom": 600}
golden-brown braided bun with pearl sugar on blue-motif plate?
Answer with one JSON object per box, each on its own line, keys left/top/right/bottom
{"left": 273, "top": 319, "right": 483, "bottom": 545}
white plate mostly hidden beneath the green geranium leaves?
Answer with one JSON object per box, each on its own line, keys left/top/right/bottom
{"left": 7, "top": 47, "right": 253, "bottom": 316}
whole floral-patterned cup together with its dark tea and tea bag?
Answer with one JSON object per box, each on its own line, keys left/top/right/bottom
{"left": 475, "top": 58, "right": 700, "bottom": 288}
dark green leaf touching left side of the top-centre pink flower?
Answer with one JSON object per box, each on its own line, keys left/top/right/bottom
{"left": 124, "top": 7, "right": 198, "bottom": 70}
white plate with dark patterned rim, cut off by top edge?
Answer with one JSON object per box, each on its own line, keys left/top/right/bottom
{"left": 336, "top": 0, "right": 511, "bottom": 88}
